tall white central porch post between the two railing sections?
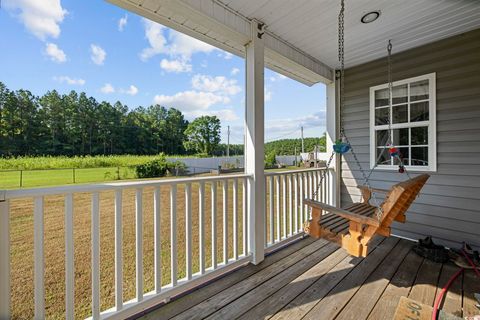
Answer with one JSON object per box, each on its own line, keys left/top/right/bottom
{"left": 245, "top": 20, "right": 265, "bottom": 264}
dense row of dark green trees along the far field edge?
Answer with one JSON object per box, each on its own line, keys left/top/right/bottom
{"left": 0, "top": 82, "right": 231, "bottom": 156}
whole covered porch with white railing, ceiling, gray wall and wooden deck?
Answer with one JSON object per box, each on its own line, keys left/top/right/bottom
{"left": 0, "top": 0, "right": 480, "bottom": 319}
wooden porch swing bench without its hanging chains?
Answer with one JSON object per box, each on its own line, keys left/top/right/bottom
{"left": 304, "top": 174, "right": 430, "bottom": 257}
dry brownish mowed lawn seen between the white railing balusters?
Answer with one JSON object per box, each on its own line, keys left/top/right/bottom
{"left": 10, "top": 180, "right": 288, "bottom": 319}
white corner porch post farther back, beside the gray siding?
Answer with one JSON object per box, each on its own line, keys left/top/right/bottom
{"left": 326, "top": 81, "right": 341, "bottom": 206}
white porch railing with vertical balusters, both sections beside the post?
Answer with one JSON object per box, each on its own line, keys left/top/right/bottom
{"left": 0, "top": 169, "right": 333, "bottom": 319}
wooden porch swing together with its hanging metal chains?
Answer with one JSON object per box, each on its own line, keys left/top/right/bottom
{"left": 304, "top": 0, "right": 430, "bottom": 257}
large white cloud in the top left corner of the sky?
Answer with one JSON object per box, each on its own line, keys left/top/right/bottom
{"left": 3, "top": 0, "right": 68, "bottom": 41}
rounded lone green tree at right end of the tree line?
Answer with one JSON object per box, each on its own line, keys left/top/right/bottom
{"left": 184, "top": 116, "right": 221, "bottom": 155}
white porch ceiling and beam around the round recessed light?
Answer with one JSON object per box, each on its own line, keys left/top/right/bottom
{"left": 107, "top": 0, "right": 480, "bottom": 85}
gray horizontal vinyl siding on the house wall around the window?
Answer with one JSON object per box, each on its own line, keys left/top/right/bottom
{"left": 341, "top": 29, "right": 480, "bottom": 247}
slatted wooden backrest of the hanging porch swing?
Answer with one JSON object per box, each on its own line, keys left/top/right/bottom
{"left": 380, "top": 174, "right": 430, "bottom": 227}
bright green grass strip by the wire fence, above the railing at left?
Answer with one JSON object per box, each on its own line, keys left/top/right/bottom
{"left": 0, "top": 167, "right": 135, "bottom": 189}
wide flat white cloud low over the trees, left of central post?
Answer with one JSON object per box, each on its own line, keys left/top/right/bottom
{"left": 153, "top": 90, "right": 230, "bottom": 112}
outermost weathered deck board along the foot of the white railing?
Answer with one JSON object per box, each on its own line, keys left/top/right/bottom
{"left": 144, "top": 237, "right": 315, "bottom": 320}
